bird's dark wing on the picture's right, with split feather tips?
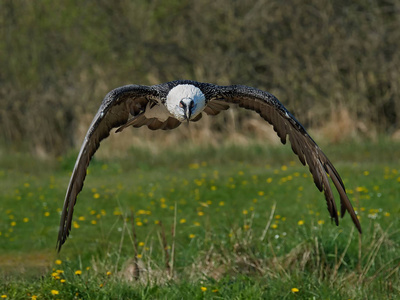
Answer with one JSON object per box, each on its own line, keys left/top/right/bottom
{"left": 212, "top": 85, "right": 361, "bottom": 233}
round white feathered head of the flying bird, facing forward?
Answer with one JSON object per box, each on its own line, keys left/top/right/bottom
{"left": 165, "top": 84, "right": 206, "bottom": 122}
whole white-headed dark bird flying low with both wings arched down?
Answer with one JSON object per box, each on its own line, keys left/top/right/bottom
{"left": 56, "top": 80, "right": 362, "bottom": 251}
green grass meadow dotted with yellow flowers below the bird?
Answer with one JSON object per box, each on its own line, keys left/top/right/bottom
{"left": 0, "top": 139, "right": 400, "bottom": 299}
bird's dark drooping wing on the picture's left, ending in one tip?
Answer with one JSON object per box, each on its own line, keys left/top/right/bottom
{"left": 57, "top": 85, "right": 172, "bottom": 251}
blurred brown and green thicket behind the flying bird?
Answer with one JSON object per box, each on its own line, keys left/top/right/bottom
{"left": 0, "top": 0, "right": 400, "bottom": 154}
